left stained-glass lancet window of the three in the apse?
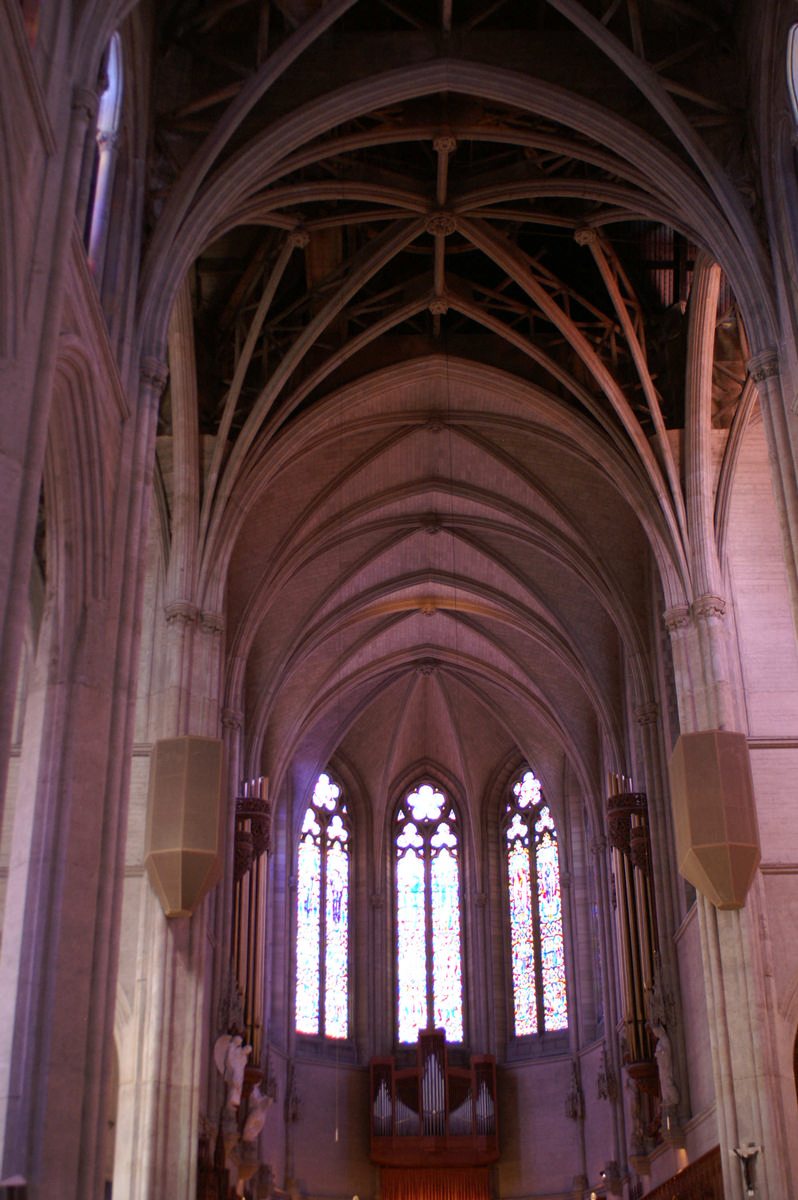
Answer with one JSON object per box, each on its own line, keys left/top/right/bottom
{"left": 296, "top": 774, "right": 352, "bottom": 1038}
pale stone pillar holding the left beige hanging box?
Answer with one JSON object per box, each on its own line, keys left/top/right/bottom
{"left": 114, "top": 601, "right": 229, "bottom": 1200}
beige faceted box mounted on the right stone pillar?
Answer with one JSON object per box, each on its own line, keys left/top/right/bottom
{"left": 670, "top": 730, "right": 760, "bottom": 908}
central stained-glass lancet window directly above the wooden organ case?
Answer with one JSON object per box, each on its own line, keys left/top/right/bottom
{"left": 394, "top": 784, "right": 463, "bottom": 1042}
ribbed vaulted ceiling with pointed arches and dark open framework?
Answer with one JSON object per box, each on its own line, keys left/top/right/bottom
{"left": 145, "top": 0, "right": 751, "bottom": 816}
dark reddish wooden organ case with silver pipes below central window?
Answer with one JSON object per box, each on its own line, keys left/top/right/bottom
{"left": 371, "top": 1030, "right": 499, "bottom": 1166}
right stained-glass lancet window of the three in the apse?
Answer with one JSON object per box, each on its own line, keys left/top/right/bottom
{"left": 504, "top": 770, "right": 568, "bottom": 1037}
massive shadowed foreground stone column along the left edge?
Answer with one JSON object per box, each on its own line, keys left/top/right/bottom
{"left": 0, "top": 326, "right": 163, "bottom": 1200}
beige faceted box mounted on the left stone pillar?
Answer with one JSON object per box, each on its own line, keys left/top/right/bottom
{"left": 144, "top": 737, "right": 224, "bottom": 917}
